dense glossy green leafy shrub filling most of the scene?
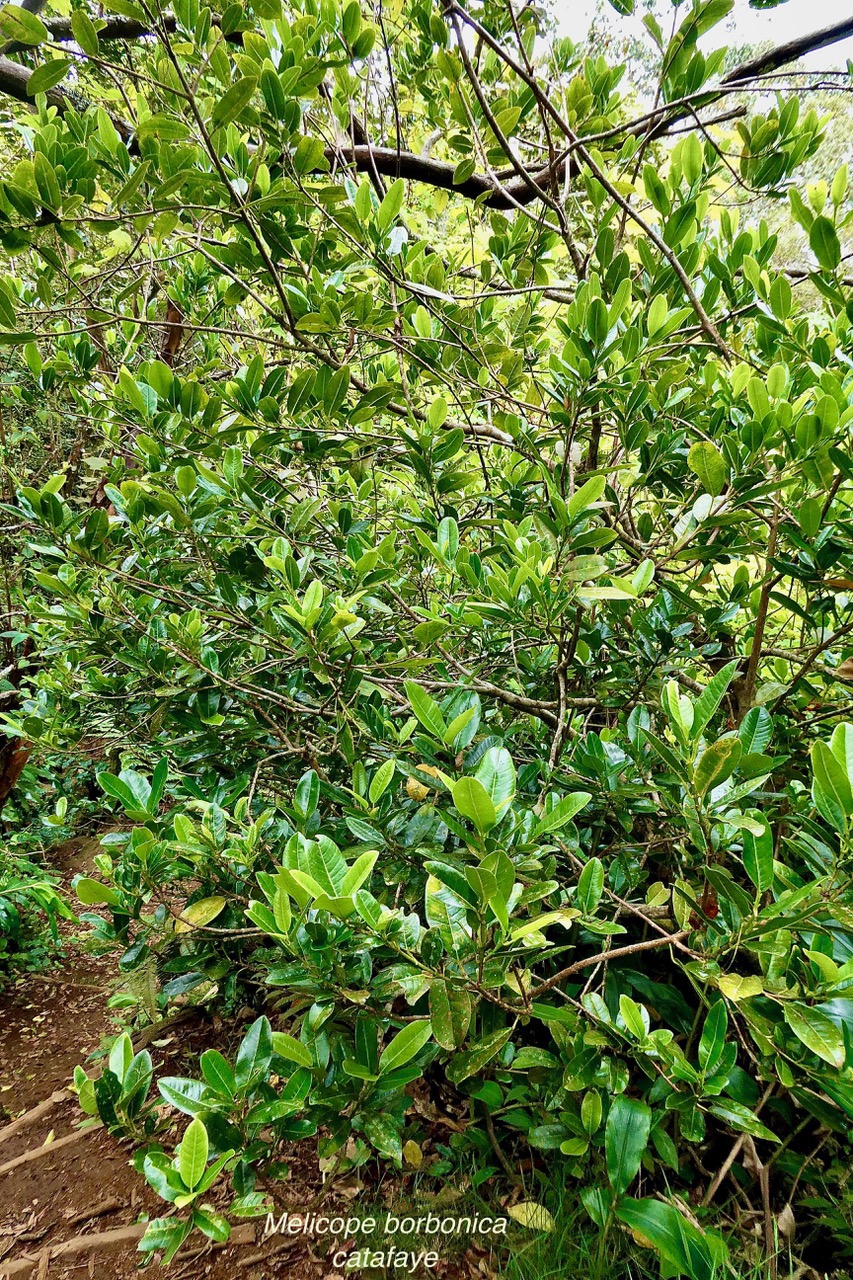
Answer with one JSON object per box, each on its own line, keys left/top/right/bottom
{"left": 0, "top": 0, "right": 853, "bottom": 1277}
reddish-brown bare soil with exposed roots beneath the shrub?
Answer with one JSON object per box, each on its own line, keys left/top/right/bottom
{"left": 0, "top": 840, "right": 496, "bottom": 1280}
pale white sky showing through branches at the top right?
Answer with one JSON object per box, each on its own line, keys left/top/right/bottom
{"left": 555, "top": 0, "right": 853, "bottom": 70}
